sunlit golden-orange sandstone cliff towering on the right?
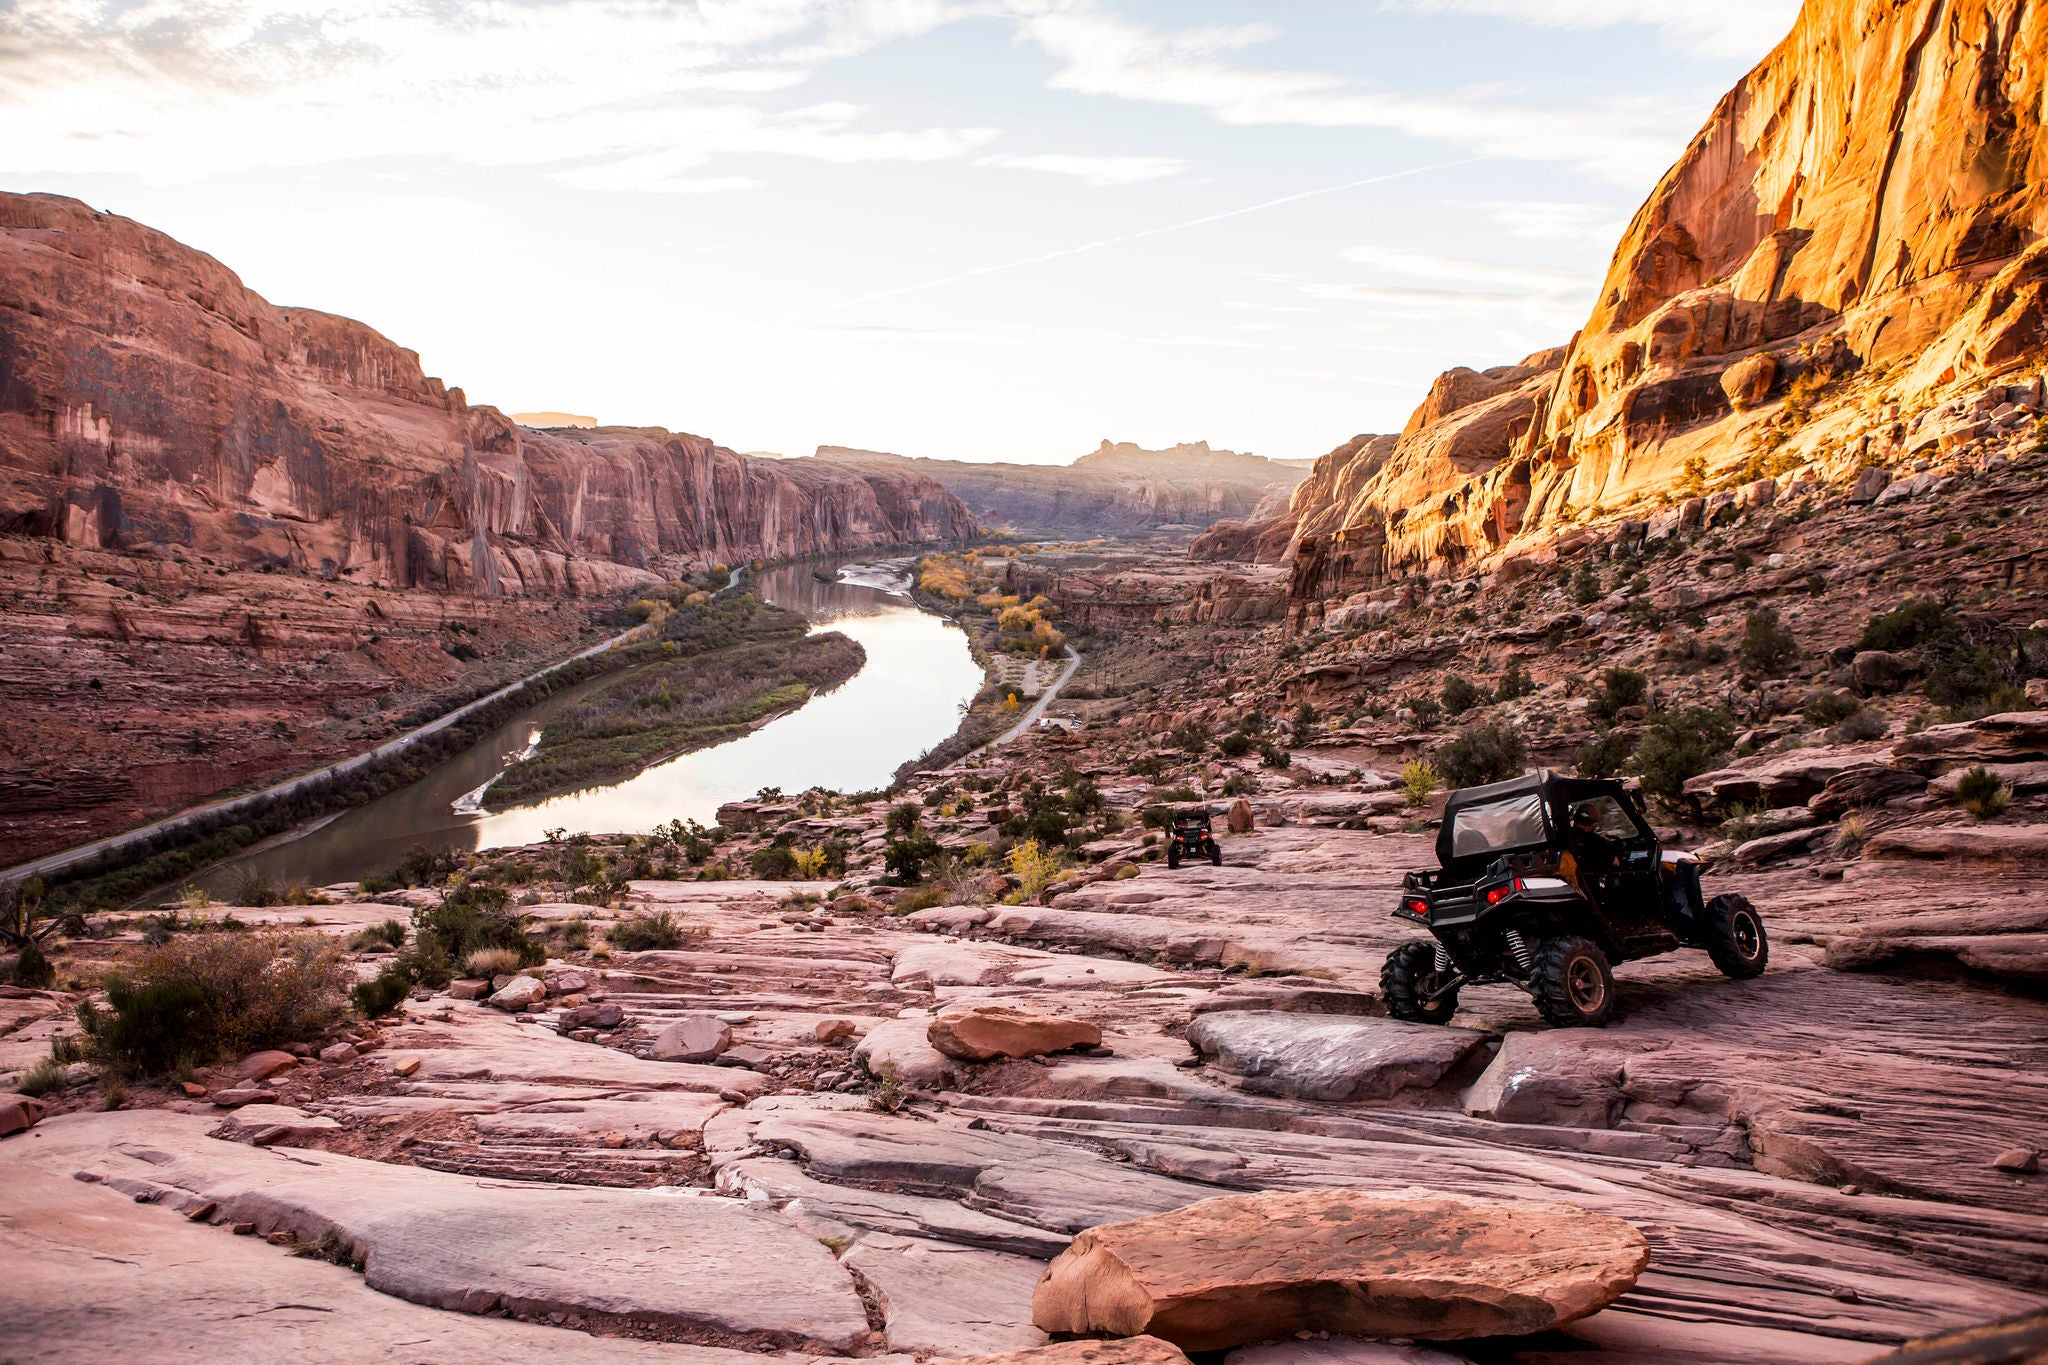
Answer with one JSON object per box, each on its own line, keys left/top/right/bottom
{"left": 1261, "top": 0, "right": 2048, "bottom": 604}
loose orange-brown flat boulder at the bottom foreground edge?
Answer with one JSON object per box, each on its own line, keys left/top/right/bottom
{"left": 1032, "top": 1189, "right": 1651, "bottom": 1351}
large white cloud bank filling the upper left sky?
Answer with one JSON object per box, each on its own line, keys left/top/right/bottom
{"left": 0, "top": 0, "right": 995, "bottom": 183}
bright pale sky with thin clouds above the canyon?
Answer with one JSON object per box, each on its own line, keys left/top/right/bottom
{"left": 0, "top": 0, "right": 1798, "bottom": 463}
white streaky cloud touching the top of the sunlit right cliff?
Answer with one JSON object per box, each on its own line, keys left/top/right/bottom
{"left": 1018, "top": 0, "right": 1698, "bottom": 184}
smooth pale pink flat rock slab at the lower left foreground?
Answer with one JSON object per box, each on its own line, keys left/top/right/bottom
{"left": 39, "top": 1111, "right": 868, "bottom": 1353}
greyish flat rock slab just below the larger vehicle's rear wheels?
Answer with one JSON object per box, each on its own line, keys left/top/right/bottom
{"left": 1188, "top": 1011, "right": 1491, "bottom": 1101}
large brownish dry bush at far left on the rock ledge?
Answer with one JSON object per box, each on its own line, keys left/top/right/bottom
{"left": 80, "top": 931, "right": 348, "bottom": 1076}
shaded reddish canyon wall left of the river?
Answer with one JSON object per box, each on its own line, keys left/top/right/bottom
{"left": 0, "top": 194, "right": 977, "bottom": 596}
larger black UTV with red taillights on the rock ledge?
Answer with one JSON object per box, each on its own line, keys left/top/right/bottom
{"left": 1380, "top": 772, "right": 1769, "bottom": 1025}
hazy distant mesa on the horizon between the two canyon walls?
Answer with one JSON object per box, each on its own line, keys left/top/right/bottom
{"left": 817, "top": 440, "right": 1307, "bottom": 536}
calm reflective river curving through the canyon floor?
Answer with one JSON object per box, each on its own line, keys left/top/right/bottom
{"left": 195, "top": 561, "right": 983, "bottom": 896}
